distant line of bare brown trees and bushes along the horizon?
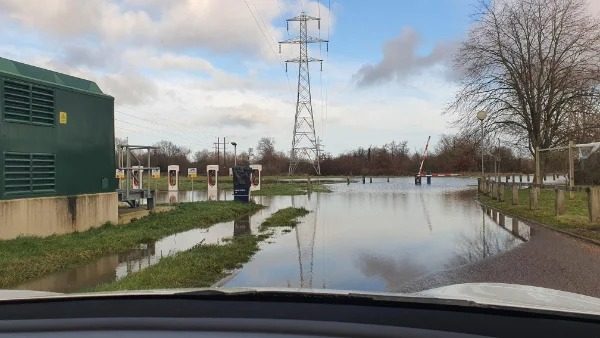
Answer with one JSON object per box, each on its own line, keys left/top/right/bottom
{"left": 116, "top": 135, "right": 532, "bottom": 176}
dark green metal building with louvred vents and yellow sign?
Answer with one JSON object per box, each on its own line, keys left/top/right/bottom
{"left": 0, "top": 58, "right": 117, "bottom": 200}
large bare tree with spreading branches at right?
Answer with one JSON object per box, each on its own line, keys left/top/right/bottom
{"left": 446, "top": 0, "right": 600, "bottom": 157}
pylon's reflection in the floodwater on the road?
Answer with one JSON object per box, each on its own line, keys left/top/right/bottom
{"left": 292, "top": 198, "right": 317, "bottom": 288}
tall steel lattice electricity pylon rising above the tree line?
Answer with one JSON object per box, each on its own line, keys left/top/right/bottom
{"left": 279, "top": 12, "right": 328, "bottom": 175}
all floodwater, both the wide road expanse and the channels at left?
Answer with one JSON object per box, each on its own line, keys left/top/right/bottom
{"left": 14, "top": 178, "right": 530, "bottom": 292}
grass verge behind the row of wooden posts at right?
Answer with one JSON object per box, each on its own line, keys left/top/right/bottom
{"left": 480, "top": 189, "right": 600, "bottom": 240}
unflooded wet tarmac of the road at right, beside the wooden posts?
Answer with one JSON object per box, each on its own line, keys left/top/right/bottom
{"left": 396, "top": 224, "right": 600, "bottom": 297}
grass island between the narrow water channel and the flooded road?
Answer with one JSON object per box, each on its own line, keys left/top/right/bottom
{"left": 89, "top": 234, "right": 268, "bottom": 291}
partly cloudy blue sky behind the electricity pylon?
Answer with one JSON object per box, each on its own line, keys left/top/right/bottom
{"left": 0, "top": 0, "right": 600, "bottom": 154}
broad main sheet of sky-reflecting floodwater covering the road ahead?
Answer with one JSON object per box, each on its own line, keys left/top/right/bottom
{"left": 224, "top": 178, "right": 530, "bottom": 291}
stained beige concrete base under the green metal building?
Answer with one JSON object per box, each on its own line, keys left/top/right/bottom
{"left": 0, "top": 192, "right": 118, "bottom": 239}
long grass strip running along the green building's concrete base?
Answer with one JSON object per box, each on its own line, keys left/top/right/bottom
{"left": 0, "top": 201, "right": 262, "bottom": 288}
